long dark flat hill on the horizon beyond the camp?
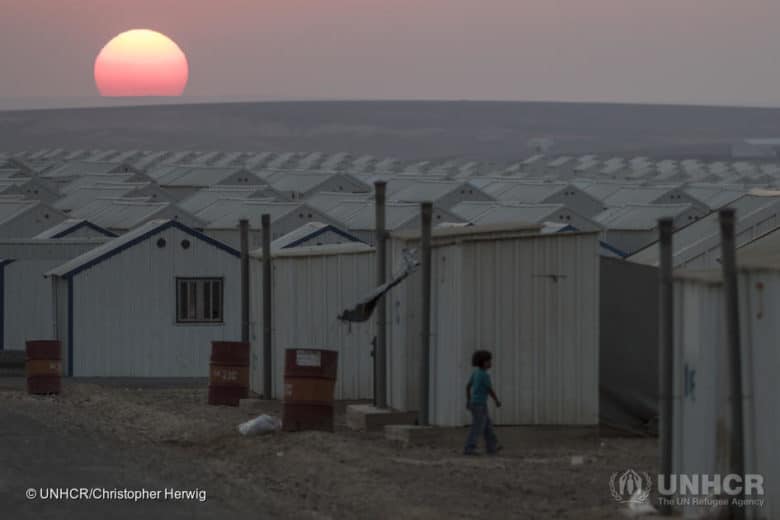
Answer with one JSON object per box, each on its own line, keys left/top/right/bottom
{"left": 0, "top": 101, "right": 780, "bottom": 161}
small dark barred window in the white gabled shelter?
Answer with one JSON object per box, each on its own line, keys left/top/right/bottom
{"left": 176, "top": 278, "right": 223, "bottom": 323}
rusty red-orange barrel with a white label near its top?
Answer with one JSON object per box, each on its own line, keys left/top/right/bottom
{"left": 282, "top": 349, "right": 339, "bottom": 432}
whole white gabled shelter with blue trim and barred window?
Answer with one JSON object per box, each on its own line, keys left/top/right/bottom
{"left": 47, "top": 220, "right": 241, "bottom": 377}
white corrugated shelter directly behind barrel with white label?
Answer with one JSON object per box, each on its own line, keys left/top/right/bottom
{"left": 251, "top": 243, "right": 376, "bottom": 399}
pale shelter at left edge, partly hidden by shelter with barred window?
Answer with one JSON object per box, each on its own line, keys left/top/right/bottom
{"left": 0, "top": 237, "right": 108, "bottom": 350}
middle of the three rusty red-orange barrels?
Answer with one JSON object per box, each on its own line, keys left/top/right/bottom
{"left": 209, "top": 341, "right": 249, "bottom": 406}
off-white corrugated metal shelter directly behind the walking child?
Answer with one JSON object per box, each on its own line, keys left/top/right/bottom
{"left": 387, "top": 226, "right": 599, "bottom": 426}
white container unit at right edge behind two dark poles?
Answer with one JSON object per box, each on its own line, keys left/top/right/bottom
{"left": 673, "top": 266, "right": 780, "bottom": 519}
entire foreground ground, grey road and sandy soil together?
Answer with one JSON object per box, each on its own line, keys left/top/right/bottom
{"left": 0, "top": 378, "right": 656, "bottom": 519}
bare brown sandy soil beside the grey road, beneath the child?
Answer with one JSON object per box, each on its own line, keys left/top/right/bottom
{"left": 0, "top": 381, "right": 656, "bottom": 519}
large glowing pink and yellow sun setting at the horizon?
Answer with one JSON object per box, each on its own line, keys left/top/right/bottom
{"left": 95, "top": 29, "right": 189, "bottom": 97}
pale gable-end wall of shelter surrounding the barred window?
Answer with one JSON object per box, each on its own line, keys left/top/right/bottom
{"left": 65, "top": 228, "right": 241, "bottom": 377}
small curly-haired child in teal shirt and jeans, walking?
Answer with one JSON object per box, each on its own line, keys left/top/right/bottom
{"left": 463, "top": 350, "right": 501, "bottom": 455}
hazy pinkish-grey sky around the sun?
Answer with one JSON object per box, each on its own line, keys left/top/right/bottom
{"left": 0, "top": 0, "right": 780, "bottom": 106}
